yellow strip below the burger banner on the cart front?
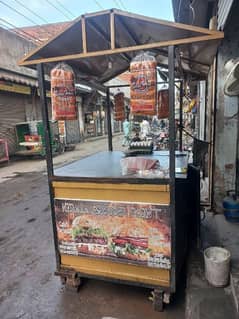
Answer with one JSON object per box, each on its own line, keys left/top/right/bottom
{"left": 61, "top": 255, "right": 170, "bottom": 287}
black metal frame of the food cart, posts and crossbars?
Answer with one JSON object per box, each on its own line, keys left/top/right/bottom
{"left": 37, "top": 46, "right": 176, "bottom": 292}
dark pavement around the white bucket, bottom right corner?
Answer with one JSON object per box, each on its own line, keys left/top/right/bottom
{"left": 185, "top": 212, "right": 239, "bottom": 319}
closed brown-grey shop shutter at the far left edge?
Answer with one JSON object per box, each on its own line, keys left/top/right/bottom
{"left": 0, "top": 92, "right": 25, "bottom": 155}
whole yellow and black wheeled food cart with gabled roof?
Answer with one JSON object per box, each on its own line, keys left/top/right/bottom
{"left": 19, "top": 9, "right": 223, "bottom": 310}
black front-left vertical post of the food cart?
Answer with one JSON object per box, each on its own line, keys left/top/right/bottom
{"left": 37, "top": 63, "right": 60, "bottom": 270}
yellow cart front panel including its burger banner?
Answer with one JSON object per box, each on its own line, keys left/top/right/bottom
{"left": 53, "top": 181, "right": 171, "bottom": 287}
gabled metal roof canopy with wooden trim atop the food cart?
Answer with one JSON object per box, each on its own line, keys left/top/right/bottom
{"left": 19, "top": 9, "right": 223, "bottom": 84}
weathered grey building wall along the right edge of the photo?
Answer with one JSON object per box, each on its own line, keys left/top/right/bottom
{"left": 213, "top": 1, "right": 239, "bottom": 211}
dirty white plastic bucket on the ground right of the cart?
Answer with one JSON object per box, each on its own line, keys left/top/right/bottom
{"left": 204, "top": 247, "right": 231, "bottom": 287}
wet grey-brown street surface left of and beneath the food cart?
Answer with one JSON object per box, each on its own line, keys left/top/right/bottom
{"left": 0, "top": 137, "right": 184, "bottom": 319}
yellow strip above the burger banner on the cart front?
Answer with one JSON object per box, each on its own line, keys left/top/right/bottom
{"left": 53, "top": 182, "right": 170, "bottom": 205}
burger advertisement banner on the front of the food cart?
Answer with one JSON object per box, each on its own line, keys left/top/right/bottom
{"left": 55, "top": 198, "right": 171, "bottom": 269}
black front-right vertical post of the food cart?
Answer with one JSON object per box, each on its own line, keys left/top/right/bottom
{"left": 168, "top": 46, "right": 176, "bottom": 291}
